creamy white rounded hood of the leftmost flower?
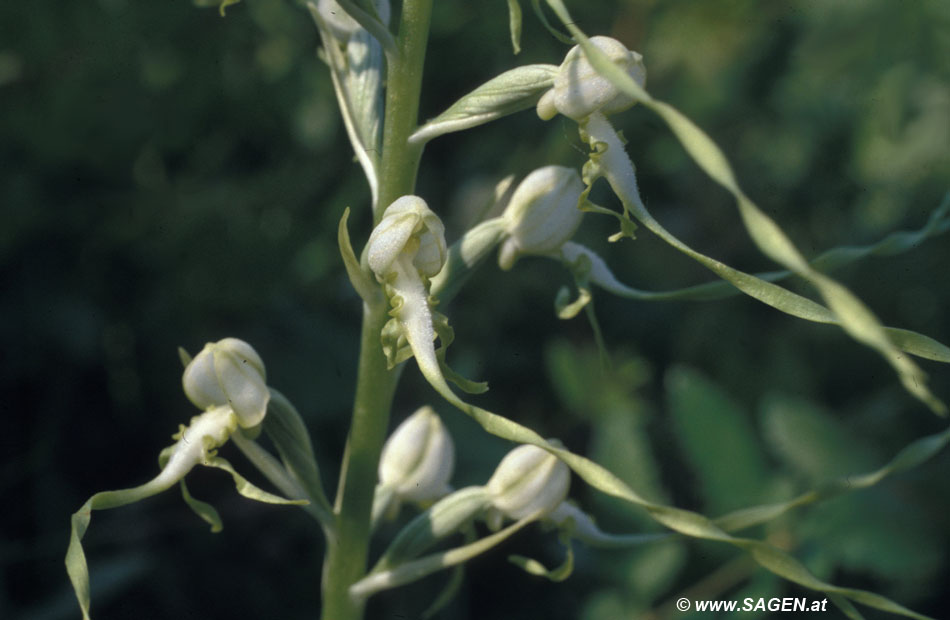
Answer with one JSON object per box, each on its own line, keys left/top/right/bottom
{"left": 182, "top": 338, "right": 270, "bottom": 428}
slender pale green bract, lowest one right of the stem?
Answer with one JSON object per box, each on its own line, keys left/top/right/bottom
{"left": 350, "top": 508, "right": 537, "bottom": 601}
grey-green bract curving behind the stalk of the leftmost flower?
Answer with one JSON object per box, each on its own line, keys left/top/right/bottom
{"left": 264, "top": 388, "right": 335, "bottom": 527}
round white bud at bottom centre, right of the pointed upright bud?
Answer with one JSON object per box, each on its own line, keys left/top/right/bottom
{"left": 487, "top": 445, "right": 571, "bottom": 519}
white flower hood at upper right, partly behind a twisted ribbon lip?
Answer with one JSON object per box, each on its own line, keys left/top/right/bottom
{"left": 537, "top": 37, "right": 647, "bottom": 121}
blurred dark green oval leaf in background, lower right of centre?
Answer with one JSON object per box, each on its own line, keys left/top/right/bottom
{"left": 665, "top": 367, "right": 769, "bottom": 513}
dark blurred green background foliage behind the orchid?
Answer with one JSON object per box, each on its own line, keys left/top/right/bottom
{"left": 0, "top": 0, "right": 950, "bottom": 620}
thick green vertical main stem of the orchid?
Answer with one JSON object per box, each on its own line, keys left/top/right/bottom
{"left": 322, "top": 0, "right": 432, "bottom": 620}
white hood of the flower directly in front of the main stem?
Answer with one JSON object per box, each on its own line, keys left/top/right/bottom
{"left": 367, "top": 196, "right": 448, "bottom": 278}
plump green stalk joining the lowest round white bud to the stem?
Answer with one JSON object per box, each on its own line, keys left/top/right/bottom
{"left": 372, "top": 486, "right": 491, "bottom": 573}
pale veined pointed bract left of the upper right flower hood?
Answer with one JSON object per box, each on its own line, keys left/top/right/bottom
{"left": 409, "top": 65, "right": 557, "bottom": 145}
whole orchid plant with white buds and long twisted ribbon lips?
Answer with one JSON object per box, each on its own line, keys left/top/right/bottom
{"left": 66, "top": 0, "right": 950, "bottom": 620}
